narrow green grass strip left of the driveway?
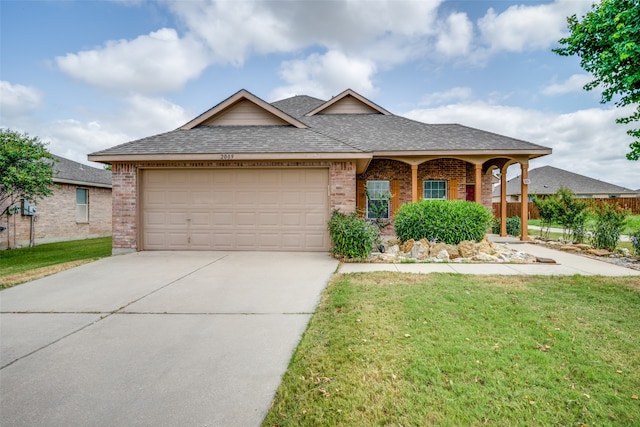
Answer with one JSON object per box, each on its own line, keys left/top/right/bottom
{"left": 0, "top": 237, "right": 111, "bottom": 289}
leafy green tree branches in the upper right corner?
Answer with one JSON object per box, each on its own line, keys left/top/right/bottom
{"left": 553, "top": 0, "right": 640, "bottom": 160}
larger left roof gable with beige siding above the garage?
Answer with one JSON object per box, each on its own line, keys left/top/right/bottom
{"left": 180, "top": 89, "right": 307, "bottom": 130}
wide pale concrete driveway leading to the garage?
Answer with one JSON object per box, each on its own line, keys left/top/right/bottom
{"left": 0, "top": 252, "right": 338, "bottom": 426}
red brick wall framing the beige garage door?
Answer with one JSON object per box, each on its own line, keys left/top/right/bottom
{"left": 112, "top": 161, "right": 356, "bottom": 253}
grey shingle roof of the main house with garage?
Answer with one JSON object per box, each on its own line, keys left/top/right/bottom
{"left": 90, "top": 89, "right": 551, "bottom": 161}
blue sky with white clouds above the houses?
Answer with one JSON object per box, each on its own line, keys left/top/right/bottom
{"left": 0, "top": 0, "right": 640, "bottom": 189}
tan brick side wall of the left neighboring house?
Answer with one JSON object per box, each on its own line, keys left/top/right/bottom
{"left": 0, "top": 184, "right": 111, "bottom": 249}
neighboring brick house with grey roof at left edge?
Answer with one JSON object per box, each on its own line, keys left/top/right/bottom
{"left": 0, "top": 155, "right": 111, "bottom": 249}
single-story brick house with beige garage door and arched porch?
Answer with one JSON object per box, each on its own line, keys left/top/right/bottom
{"left": 89, "top": 89, "right": 551, "bottom": 253}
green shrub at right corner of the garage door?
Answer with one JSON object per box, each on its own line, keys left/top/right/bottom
{"left": 328, "top": 210, "right": 380, "bottom": 258}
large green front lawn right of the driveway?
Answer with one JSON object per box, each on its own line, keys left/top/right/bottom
{"left": 263, "top": 273, "right": 640, "bottom": 426}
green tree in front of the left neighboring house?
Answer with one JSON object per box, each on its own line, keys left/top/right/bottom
{"left": 0, "top": 129, "right": 54, "bottom": 216}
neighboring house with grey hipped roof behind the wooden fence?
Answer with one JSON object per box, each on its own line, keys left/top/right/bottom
{"left": 493, "top": 166, "right": 638, "bottom": 202}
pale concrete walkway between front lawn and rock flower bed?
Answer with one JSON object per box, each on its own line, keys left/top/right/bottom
{"left": 338, "top": 243, "right": 640, "bottom": 276}
